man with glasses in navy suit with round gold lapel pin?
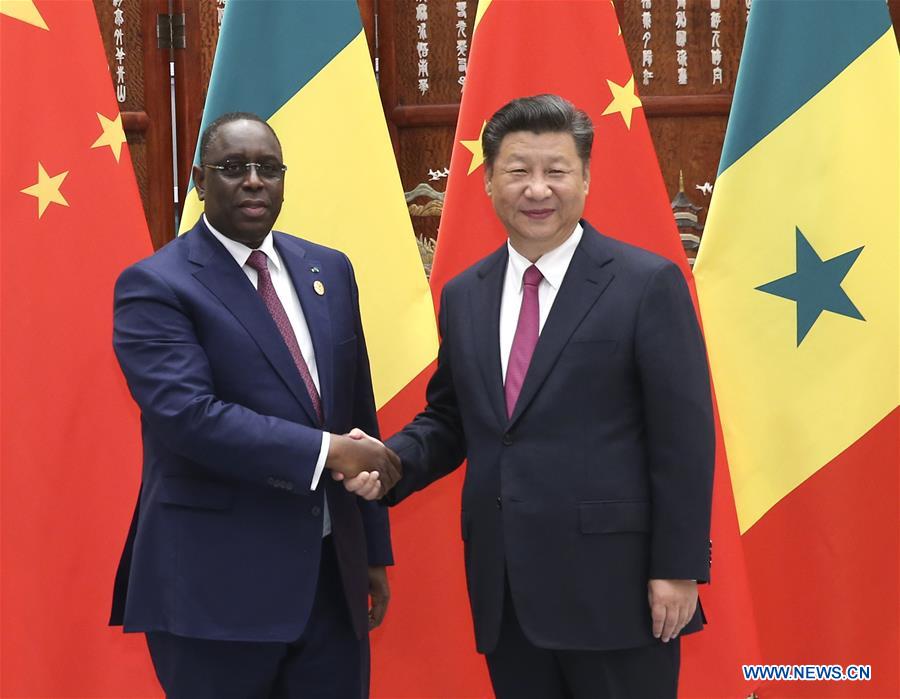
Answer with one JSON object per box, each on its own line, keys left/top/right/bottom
{"left": 112, "top": 113, "right": 399, "bottom": 699}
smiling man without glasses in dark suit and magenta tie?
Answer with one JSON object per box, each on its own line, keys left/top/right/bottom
{"left": 351, "top": 95, "right": 714, "bottom": 699}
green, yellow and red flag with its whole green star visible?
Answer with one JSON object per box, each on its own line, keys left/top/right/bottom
{"left": 694, "top": 0, "right": 900, "bottom": 697}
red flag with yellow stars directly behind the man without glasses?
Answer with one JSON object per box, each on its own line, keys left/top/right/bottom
{"left": 374, "top": 0, "right": 759, "bottom": 697}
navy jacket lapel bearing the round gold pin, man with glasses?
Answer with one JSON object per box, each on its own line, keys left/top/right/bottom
{"left": 275, "top": 237, "right": 334, "bottom": 424}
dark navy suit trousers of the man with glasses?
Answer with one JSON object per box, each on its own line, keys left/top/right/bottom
{"left": 147, "top": 536, "right": 369, "bottom": 699}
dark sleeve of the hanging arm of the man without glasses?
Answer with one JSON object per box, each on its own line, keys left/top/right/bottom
{"left": 635, "top": 263, "right": 715, "bottom": 582}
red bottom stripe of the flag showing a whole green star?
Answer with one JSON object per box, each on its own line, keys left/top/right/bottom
{"left": 743, "top": 408, "right": 900, "bottom": 699}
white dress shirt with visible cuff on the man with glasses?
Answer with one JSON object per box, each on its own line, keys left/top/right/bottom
{"left": 203, "top": 214, "right": 331, "bottom": 536}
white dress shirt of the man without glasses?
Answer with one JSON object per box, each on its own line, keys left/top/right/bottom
{"left": 500, "top": 223, "right": 584, "bottom": 383}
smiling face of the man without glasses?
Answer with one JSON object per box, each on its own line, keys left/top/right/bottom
{"left": 484, "top": 131, "right": 591, "bottom": 262}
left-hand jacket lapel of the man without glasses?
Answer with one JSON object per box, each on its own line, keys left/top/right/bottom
{"left": 469, "top": 245, "right": 509, "bottom": 432}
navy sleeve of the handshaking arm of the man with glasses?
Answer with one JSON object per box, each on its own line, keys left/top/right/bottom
{"left": 113, "top": 264, "right": 322, "bottom": 492}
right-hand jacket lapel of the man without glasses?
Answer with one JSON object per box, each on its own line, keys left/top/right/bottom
{"left": 509, "top": 230, "right": 613, "bottom": 426}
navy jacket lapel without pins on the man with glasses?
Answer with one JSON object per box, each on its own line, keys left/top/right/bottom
{"left": 187, "top": 223, "right": 317, "bottom": 424}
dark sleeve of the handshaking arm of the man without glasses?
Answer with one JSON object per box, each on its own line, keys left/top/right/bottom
{"left": 385, "top": 290, "right": 466, "bottom": 505}
